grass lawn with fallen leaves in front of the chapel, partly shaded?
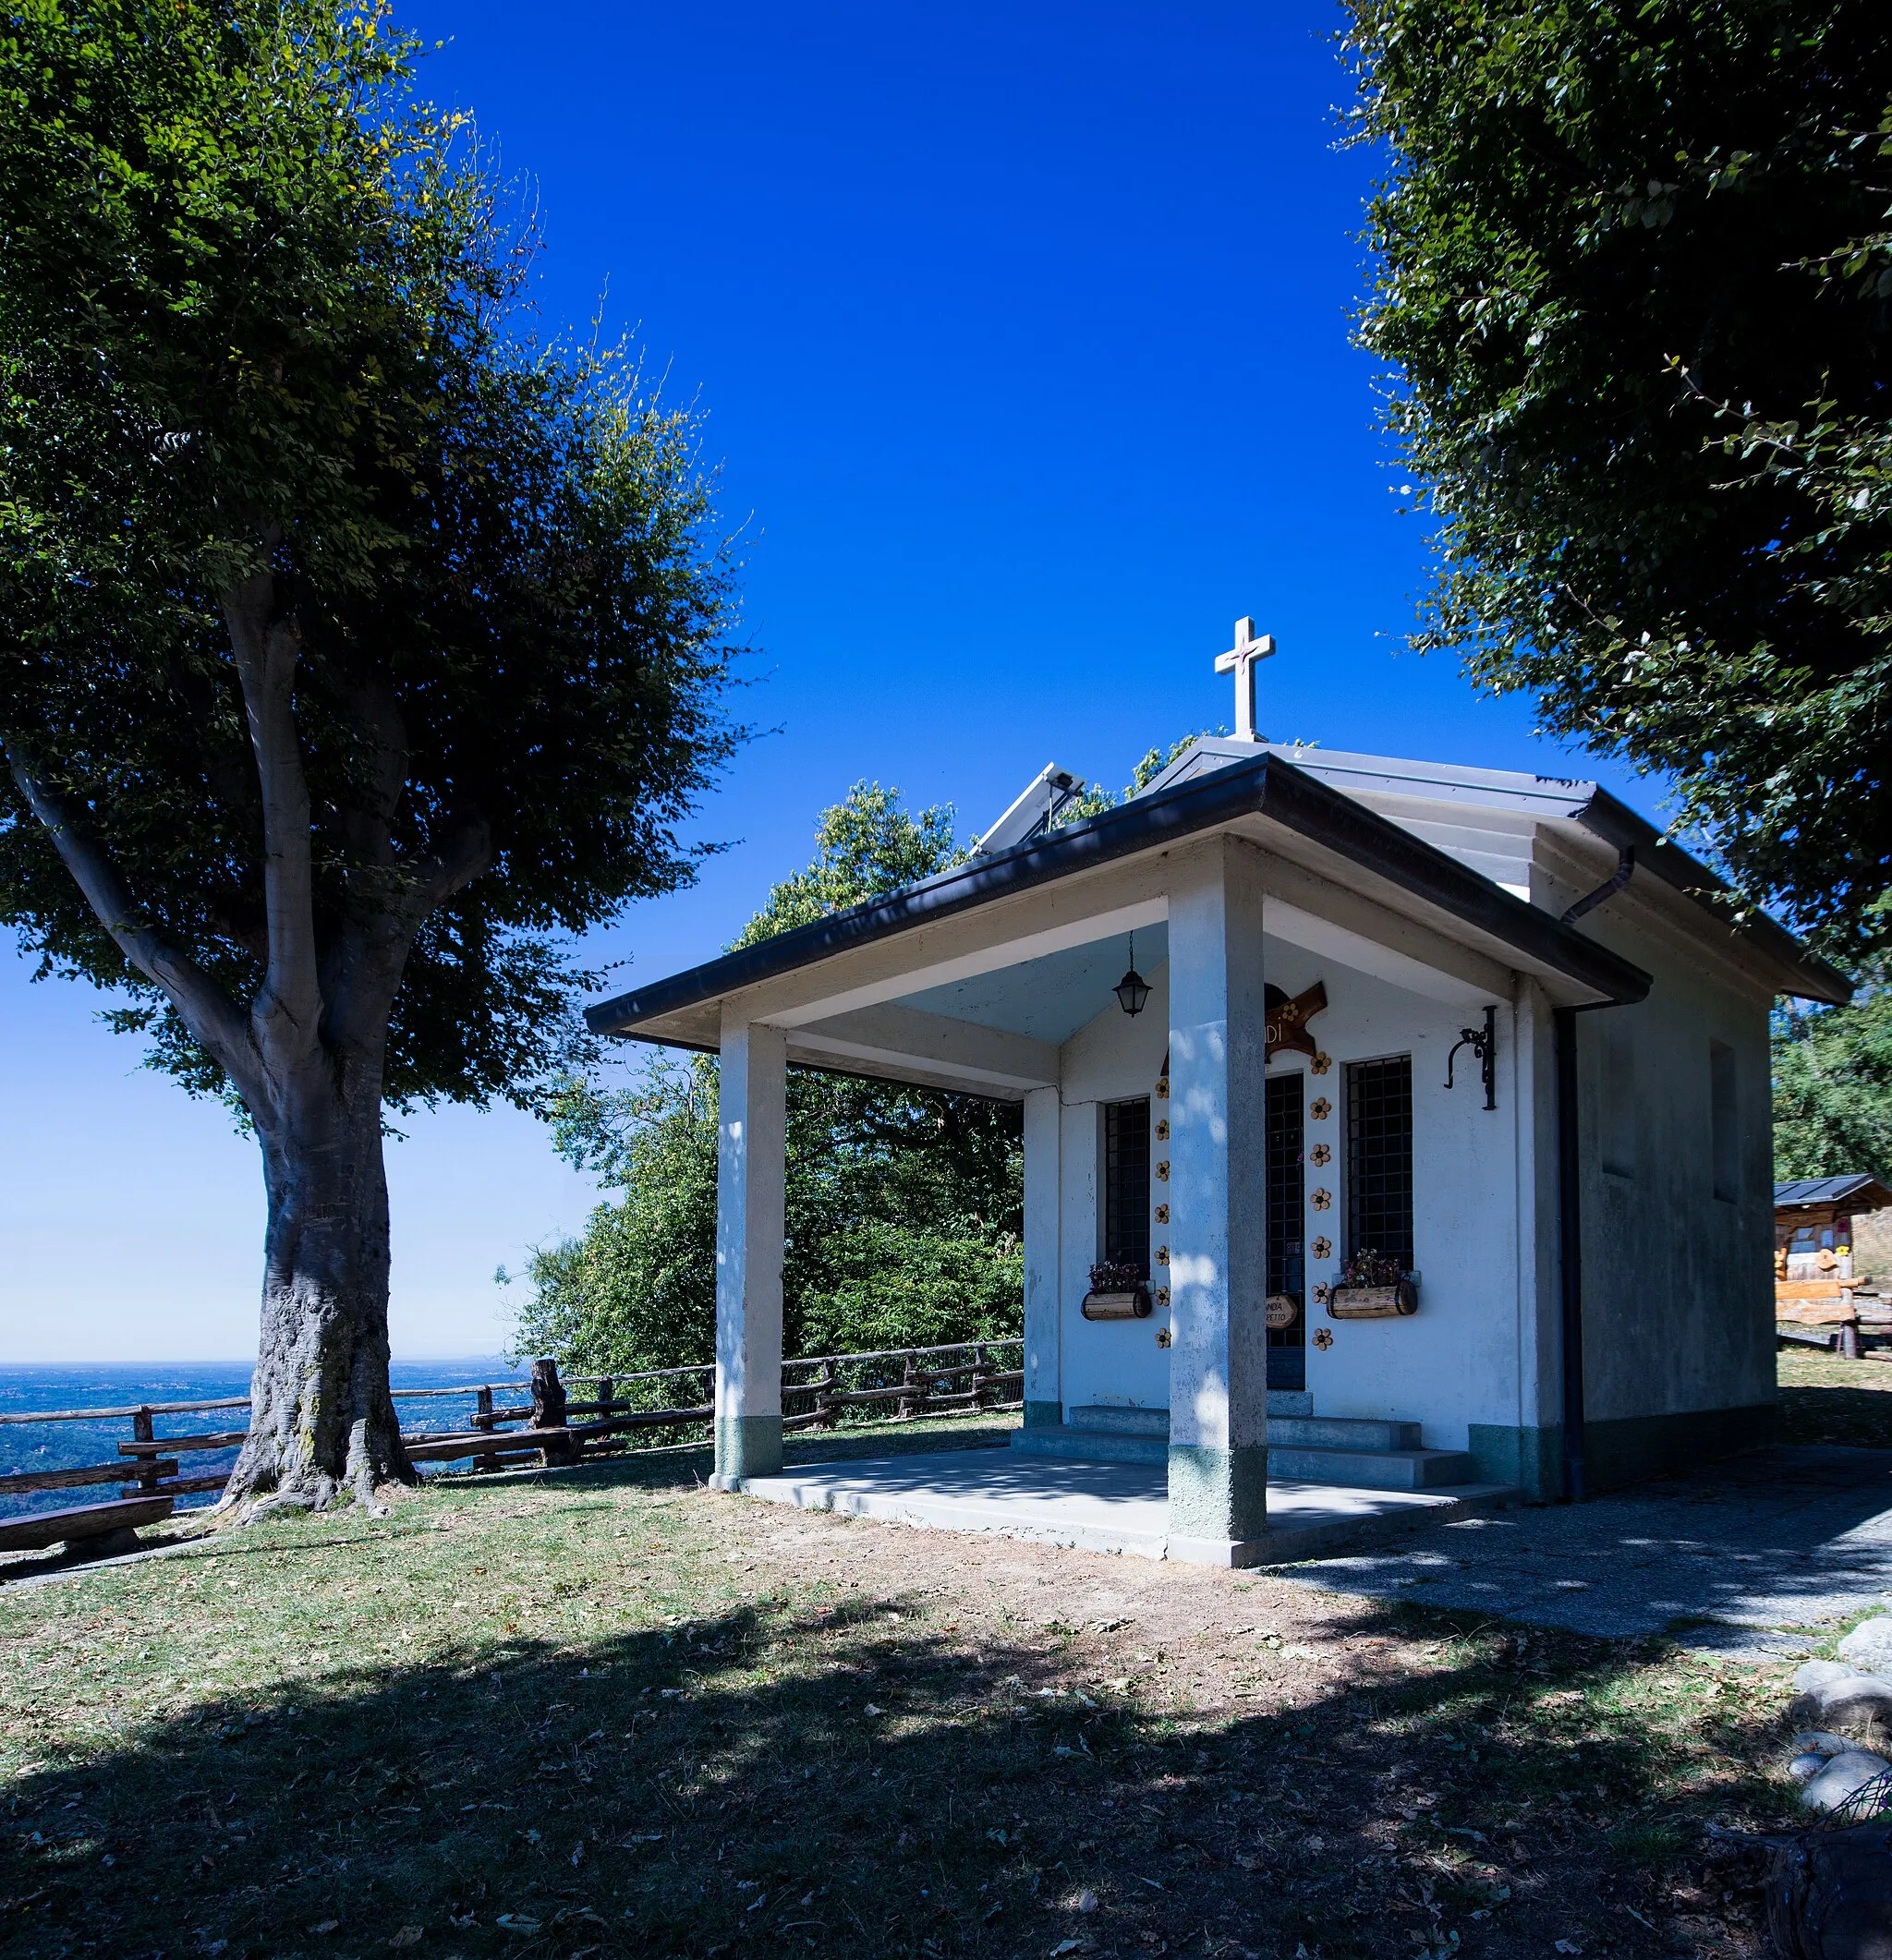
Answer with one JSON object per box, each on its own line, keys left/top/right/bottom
{"left": 0, "top": 1419, "right": 1842, "bottom": 1960}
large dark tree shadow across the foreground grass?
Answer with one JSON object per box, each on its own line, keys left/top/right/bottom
{"left": 0, "top": 1583, "right": 1778, "bottom": 1960}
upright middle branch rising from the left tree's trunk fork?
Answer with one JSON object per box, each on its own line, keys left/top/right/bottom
{"left": 224, "top": 571, "right": 321, "bottom": 1071}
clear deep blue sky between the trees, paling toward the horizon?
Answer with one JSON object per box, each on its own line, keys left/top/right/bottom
{"left": 0, "top": 0, "right": 1655, "bottom": 1361}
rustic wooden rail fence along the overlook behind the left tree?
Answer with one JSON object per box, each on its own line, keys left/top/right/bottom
{"left": 0, "top": 1338, "right": 1024, "bottom": 1553}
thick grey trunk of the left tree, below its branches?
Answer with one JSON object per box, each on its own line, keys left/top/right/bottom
{"left": 222, "top": 1048, "right": 418, "bottom": 1515}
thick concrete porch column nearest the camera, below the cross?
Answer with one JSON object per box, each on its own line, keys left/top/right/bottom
{"left": 1157, "top": 837, "right": 1268, "bottom": 1564}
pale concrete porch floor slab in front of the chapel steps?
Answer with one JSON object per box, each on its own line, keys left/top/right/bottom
{"left": 743, "top": 1448, "right": 1520, "bottom": 1566}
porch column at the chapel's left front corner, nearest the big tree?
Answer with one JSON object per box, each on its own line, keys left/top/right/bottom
{"left": 710, "top": 1013, "right": 788, "bottom": 1490}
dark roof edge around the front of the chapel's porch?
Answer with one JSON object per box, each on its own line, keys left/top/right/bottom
{"left": 584, "top": 755, "right": 1649, "bottom": 1039}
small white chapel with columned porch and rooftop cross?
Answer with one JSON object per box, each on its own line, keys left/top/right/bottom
{"left": 590, "top": 620, "right": 1850, "bottom": 1564}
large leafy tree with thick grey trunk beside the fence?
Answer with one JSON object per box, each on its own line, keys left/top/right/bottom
{"left": 0, "top": 0, "right": 732, "bottom": 1504}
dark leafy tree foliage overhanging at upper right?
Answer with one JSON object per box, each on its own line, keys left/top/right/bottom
{"left": 1349, "top": 0, "right": 1892, "bottom": 957}
